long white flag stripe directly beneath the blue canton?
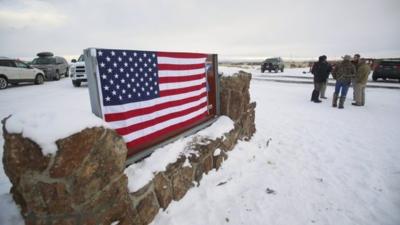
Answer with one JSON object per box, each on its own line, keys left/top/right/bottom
{"left": 104, "top": 87, "right": 206, "bottom": 114}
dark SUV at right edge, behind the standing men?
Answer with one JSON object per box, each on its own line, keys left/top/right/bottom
{"left": 372, "top": 60, "right": 400, "bottom": 82}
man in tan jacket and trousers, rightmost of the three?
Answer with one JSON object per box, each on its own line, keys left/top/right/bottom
{"left": 351, "top": 59, "right": 371, "bottom": 106}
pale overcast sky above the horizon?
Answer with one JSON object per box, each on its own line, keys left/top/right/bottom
{"left": 0, "top": 0, "right": 400, "bottom": 59}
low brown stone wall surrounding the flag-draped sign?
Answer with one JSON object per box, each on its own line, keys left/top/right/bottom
{"left": 3, "top": 72, "right": 256, "bottom": 225}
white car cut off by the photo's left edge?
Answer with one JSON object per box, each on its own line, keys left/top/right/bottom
{"left": 0, "top": 57, "right": 44, "bottom": 89}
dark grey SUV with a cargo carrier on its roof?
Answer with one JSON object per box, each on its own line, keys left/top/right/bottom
{"left": 31, "top": 52, "right": 69, "bottom": 80}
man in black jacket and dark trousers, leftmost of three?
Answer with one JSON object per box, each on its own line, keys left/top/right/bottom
{"left": 311, "top": 55, "right": 332, "bottom": 103}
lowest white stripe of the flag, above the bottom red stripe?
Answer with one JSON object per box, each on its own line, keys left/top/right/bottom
{"left": 123, "top": 107, "right": 207, "bottom": 142}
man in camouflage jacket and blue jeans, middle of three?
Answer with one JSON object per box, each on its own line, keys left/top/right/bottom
{"left": 332, "top": 55, "right": 356, "bottom": 109}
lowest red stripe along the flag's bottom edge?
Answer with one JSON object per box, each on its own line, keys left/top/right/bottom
{"left": 127, "top": 113, "right": 207, "bottom": 148}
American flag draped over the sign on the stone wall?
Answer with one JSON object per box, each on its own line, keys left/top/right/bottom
{"left": 96, "top": 49, "right": 208, "bottom": 151}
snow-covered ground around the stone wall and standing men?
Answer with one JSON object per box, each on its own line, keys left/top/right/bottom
{"left": 0, "top": 67, "right": 400, "bottom": 225}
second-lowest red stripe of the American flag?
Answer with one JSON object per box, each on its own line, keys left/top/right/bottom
{"left": 116, "top": 102, "right": 207, "bottom": 135}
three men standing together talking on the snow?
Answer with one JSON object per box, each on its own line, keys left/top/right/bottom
{"left": 311, "top": 54, "right": 371, "bottom": 109}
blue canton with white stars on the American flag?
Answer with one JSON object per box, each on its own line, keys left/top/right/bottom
{"left": 97, "top": 49, "right": 160, "bottom": 106}
